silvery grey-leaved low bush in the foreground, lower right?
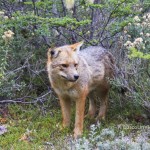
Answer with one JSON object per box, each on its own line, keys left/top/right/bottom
{"left": 72, "top": 124, "right": 150, "bottom": 150}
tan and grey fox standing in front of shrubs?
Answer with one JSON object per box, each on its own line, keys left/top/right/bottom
{"left": 47, "top": 41, "right": 114, "bottom": 138}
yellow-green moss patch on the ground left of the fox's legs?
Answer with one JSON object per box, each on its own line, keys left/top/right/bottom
{"left": 0, "top": 105, "right": 70, "bottom": 150}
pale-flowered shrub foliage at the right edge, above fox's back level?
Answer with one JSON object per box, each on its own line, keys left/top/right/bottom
{"left": 124, "top": 13, "right": 150, "bottom": 59}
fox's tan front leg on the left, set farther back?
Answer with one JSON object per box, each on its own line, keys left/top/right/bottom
{"left": 59, "top": 98, "right": 71, "bottom": 128}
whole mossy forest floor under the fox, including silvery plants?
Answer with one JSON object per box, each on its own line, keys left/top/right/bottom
{"left": 0, "top": 101, "right": 150, "bottom": 150}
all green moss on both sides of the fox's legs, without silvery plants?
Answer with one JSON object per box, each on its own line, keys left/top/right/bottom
{"left": 0, "top": 99, "right": 148, "bottom": 150}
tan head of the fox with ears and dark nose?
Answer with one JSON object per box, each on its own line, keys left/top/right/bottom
{"left": 47, "top": 42, "right": 83, "bottom": 82}
